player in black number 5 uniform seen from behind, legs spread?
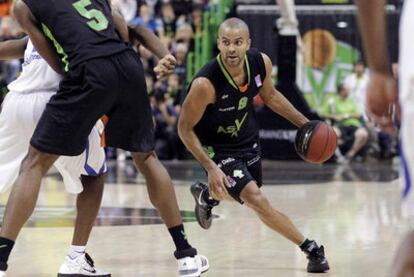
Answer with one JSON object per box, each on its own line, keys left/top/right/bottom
{"left": 0, "top": 0, "right": 208, "bottom": 276}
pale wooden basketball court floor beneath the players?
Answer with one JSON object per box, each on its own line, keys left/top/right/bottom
{"left": 0, "top": 158, "right": 414, "bottom": 277}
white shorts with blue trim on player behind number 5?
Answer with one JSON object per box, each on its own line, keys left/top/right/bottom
{"left": 0, "top": 92, "right": 106, "bottom": 193}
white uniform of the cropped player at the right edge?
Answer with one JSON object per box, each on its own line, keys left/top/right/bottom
{"left": 399, "top": 1, "right": 414, "bottom": 193}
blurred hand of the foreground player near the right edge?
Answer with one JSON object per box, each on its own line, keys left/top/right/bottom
{"left": 367, "top": 72, "right": 399, "bottom": 133}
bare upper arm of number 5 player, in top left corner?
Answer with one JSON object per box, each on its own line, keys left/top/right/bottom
{"left": 13, "top": 0, "right": 64, "bottom": 74}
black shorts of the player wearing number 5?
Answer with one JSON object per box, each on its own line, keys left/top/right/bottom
{"left": 30, "top": 50, "right": 154, "bottom": 156}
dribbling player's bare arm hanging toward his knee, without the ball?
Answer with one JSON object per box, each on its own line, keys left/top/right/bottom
{"left": 178, "top": 77, "right": 227, "bottom": 199}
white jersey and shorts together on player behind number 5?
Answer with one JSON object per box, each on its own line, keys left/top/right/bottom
{"left": 0, "top": 40, "right": 106, "bottom": 193}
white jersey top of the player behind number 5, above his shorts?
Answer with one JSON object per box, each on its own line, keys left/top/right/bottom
{"left": 8, "top": 39, "right": 62, "bottom": 93}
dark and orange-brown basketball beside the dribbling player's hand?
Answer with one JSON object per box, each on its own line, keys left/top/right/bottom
{"left": 295, "top": 120, "right": 337, "bottom": 164}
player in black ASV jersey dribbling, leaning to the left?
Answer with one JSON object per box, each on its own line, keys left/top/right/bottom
{"left": 178, "top": 18, "right": 329, "bottom": 273}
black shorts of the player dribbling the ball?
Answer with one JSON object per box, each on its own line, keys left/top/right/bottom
{"left": 213, "top": 151, "right": 262, "bottom": 204}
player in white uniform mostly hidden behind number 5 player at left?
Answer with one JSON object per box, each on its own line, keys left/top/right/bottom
{"left": 0, "top": 35, "right": 111, "bottom": 276}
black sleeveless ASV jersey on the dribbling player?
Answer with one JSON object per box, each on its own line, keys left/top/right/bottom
{"left": 190, "top": 49, "right": 266, "bottom": 156}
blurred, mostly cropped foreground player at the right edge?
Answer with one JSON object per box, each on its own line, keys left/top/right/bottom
{"left": 356, "top": 0, "right": 414, "bottom": 277}
